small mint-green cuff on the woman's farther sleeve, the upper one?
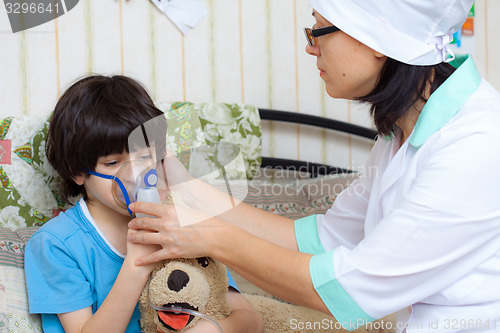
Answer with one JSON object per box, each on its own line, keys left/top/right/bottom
{"left": 294, "top": 215, "right": 325, "bottom": 254}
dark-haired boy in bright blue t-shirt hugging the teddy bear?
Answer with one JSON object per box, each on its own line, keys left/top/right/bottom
{"left": 25, "top": 76, "right": 262, "bottom": 333}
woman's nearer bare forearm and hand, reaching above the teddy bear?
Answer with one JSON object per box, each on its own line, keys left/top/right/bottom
{"left": 125, "top": 203, "right": 329, "bottom": 314}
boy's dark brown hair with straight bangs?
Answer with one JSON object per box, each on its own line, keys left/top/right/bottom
{"left": 46, "top": 75, "right": 166, "bottom": 202}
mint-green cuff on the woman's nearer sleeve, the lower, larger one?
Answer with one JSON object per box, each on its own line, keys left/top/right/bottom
{"left": 309, "top": 250, "right": 375, "bottom": 331}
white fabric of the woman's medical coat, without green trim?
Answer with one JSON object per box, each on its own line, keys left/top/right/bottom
{"left": 317, "top": 81, "right": 500, "bottom": 333}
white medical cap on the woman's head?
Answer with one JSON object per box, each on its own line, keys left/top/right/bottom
{"left": 309, "top": 0, "right": 474, "bottom": 65}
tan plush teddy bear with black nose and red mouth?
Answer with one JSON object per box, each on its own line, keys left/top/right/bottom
{"left": 139, "top": 257, "right": 394, "bottom": 333}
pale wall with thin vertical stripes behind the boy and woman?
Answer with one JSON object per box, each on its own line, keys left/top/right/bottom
{"left": 0, "top": 0, "right": 500, "bottom": 168}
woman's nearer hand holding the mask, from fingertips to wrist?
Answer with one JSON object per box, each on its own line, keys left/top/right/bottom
{"left": 128, "top": 202, "right": 227, "bottom": 265}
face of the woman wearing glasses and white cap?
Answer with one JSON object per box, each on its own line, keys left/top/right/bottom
{"left": 306, "top": 11, "right": 386, "bottom": 99}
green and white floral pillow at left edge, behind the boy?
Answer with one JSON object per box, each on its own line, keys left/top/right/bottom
{"left": 0, "top": 115, "right": 63, "bottom": 229}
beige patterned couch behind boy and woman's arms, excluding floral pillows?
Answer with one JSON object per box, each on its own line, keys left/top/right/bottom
{"left": 0, "top": 175, "right": 356, "bottom": 332}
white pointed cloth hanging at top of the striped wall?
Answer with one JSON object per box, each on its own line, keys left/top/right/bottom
{"left": 151, "top": 0, "right": 207, "bottom": 35}
